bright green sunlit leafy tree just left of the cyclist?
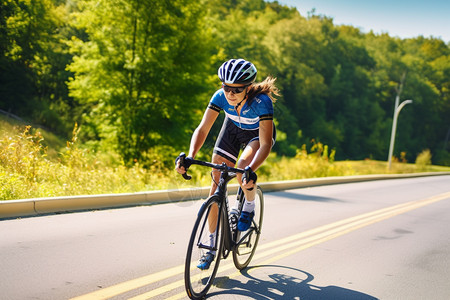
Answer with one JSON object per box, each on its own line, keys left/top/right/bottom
{"left": 69, "top": 0, "right": 214, "bottom": 163}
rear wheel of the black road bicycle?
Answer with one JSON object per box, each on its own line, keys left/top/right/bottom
{"left": 233, "top": 186, "right": 264, "bottom": 270}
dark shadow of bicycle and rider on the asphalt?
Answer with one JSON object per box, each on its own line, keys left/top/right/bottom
{"left": 208, "top": 265, "right": 378, "bottom": 300}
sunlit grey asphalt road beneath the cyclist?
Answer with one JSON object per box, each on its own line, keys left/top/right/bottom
{"left": 0, "top": 175, "right": 450, "bottom": 300}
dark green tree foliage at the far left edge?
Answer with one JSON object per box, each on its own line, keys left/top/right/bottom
{"left": 0, "top": 0, "right": 74, "bottom": 135}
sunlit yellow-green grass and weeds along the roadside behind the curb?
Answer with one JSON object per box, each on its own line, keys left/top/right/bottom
{"left": 0, "top": 119, "right": 450, "bottom": 200}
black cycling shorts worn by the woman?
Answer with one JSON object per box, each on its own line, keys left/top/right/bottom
{"left": 214, "top": 117, "right": 277, "bottom": 164}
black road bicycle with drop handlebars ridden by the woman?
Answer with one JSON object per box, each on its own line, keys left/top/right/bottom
{"left": 179, "top": 153, "right": 264, "bottom": 299}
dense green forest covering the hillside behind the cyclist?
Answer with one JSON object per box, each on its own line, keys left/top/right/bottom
{"left": 0, "top": 0, "right": 450, "bottom": 167}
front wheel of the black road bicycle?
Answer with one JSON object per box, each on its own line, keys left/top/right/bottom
{"left": 184, "top": 195, "right": 224, "bottom": 299}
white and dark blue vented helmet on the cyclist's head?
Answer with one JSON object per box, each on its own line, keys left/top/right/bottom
{"left": 217, "top": 58, "right": 257, "bottom": 84}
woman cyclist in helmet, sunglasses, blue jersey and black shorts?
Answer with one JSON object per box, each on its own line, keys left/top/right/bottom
{"left": 176, "top": 59, "right": 279, "bottom": 269}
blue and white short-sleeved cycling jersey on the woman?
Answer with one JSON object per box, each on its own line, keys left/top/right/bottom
{"left": 208, "top": 89, "right": 273, "bottom": 130}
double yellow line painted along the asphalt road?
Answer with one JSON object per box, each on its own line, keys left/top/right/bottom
{"left": 73, "top": 192, "right": 450, "bottom": 300}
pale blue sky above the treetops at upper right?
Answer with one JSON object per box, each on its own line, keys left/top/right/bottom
{"left": 278, "top": 0, "right": 450, "bottom": 43}
